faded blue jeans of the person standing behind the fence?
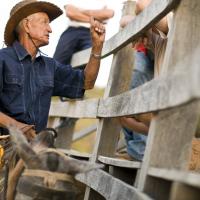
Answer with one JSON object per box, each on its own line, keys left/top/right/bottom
{"left": 122, "top": 52, "right": 154, "bottom": 161}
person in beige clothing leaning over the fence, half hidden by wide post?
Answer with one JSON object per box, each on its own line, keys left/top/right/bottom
{"left": 116, "top": 0, "right": 200, "bottom": 172}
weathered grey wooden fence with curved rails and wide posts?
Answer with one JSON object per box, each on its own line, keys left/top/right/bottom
{"left": 49, "top": 0, "right": 200, "bottom": 200}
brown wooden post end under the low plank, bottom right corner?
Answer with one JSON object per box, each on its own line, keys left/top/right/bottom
{"left": 169, "top": 183, "right": 200, "bottom": 200}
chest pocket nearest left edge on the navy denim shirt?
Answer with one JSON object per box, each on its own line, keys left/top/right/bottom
{"left": 2, "top": 74, "right": 23, "bottom": 108}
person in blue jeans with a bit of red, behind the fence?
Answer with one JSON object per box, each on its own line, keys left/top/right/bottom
{"left": 115, "top": 10, "right": 154, "bottom": 161}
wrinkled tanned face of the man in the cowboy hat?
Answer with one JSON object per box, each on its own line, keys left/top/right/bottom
{"left": 28, "top": 12, "right": 52, "bottom": 47}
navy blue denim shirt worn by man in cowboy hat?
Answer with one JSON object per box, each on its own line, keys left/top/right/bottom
{"left": 0, "top": 41, "right": 85, "bottom": 135}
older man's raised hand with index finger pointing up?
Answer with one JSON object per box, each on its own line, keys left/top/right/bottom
{"left": 90, "top": 12, "right": 106, "bottom": 46}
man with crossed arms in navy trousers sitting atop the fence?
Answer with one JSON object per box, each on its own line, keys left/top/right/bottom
{"left": 54, "top": 0, "right": 114, "bottom": 64}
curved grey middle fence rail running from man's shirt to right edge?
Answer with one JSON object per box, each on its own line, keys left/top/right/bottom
{"left": 49, "top": 46, "right": 200, "bottom": 118}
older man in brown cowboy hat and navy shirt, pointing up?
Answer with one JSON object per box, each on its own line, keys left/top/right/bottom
{"left": 0, "top": 0, "right": 105, "bottom": 138}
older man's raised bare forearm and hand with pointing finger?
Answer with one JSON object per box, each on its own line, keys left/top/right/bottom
{"left": 83, "top": 12, "right": 105, "bottom": 90}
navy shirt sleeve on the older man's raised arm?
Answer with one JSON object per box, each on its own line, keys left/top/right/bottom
{"left": 52, "top": 61, "right": 85, "bottom": 99}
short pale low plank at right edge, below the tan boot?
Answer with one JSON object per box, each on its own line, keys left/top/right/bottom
{"left": 148, "top": 168, "right": 200, "bottom": 188}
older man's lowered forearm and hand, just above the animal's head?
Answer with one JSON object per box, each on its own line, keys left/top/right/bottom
{"left": 0, "top": 112, "right": 36, "bottom": 139}
